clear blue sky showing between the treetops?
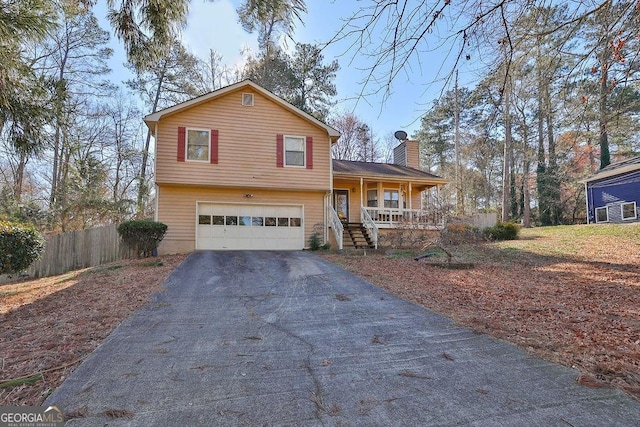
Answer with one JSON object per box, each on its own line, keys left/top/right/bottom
{"left": 96, "top": 0, "right": 480, "bottom": 139}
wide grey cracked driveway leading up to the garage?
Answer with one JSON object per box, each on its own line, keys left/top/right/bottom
{"left": 45, "top": 252, "right": 640, "bottom": 427}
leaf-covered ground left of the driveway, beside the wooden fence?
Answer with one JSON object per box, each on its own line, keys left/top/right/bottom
{"left": 0, "top": 255, "right": 185, "bottom": 405}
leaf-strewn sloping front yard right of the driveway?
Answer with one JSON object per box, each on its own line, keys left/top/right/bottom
{"left": 325, "top": 224, "right": 640, "bottom": 397}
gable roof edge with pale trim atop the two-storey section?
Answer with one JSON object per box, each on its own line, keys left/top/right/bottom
{"left": 143, "top": 79, "right": 340, "bottom": 142}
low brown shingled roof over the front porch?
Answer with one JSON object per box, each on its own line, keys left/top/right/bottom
{"left": 333, "top": 159, "right": 449, "bottom": 184}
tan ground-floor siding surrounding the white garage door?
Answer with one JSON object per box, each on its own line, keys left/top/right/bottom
{"left": 157, "top": 185, "right": 325, "bottom": 254}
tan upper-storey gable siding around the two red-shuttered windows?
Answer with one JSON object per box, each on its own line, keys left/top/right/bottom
{"left": 156, "top": 87, "right": 331, "bottom": 191}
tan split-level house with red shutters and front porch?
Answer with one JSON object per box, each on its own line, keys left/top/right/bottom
{"left": 144, "top": 80, "right": 447, "bottom": 253}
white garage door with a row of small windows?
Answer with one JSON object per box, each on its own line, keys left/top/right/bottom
{"left": 196, "top": 202, "right": 304, "bottom": 250}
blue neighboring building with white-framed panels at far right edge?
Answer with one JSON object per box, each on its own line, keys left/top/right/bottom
{"left": 582, "top": 156, "right": 640, "bottom": 224}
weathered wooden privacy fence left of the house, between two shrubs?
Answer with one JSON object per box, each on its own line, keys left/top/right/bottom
{"left": 27, "top": 225, "right": 128, "bottom": 277}
